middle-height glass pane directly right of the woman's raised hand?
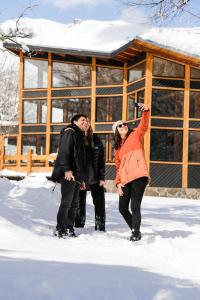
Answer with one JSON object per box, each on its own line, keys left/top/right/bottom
{"left": 152, "top": 89, "right": 184, "bottom": 117}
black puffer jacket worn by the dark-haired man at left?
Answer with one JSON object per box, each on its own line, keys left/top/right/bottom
{"left": 52, "top": 124, "right": 86, "bottom": 182}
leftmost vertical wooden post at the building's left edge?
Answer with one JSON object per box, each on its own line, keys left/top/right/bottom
{"left": 17, "top": 51, "right": 24, "bottom": 168}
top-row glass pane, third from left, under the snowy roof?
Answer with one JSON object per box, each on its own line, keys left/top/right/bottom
{"left": 97, "top": 67, "right": 123, "bottom": 85}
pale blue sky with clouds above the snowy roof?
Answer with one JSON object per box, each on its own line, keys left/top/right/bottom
{"left": 0, "top": 0, "right": 200, "bottom": 27}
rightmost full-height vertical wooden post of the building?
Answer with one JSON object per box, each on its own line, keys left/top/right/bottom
{"left": 182, "top": 65, "right": 190, "bottom": 188}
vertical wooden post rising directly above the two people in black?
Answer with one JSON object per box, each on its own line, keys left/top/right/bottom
{"left": 91, "top": 57, "right": 97, "bottom": 131}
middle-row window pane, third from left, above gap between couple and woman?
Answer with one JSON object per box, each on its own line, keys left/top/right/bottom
{"left": 96, "top": 97, "right": 122, "bottom": 122}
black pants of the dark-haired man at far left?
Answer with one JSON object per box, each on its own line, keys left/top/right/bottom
{"left": 57, "top": 179, "right": 80, "bottom": 232}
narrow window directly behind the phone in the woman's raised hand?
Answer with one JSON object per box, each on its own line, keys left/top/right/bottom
{"left": 127, "top": 90, "right": 144, "bottom": 120}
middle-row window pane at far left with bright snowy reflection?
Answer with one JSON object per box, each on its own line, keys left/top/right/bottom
{"left": 23, "top": 100, "right": 47, "bottom": 124}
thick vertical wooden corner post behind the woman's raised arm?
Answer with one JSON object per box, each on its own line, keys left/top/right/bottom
{"left": 144, "top": 53, "right": 153, "bottom": 170}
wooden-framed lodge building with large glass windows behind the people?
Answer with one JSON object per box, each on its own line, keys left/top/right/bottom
{"left": 1, "top": 20, "right": 200, "bottom": 192}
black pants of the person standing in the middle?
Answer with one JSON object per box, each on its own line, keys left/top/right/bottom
{"left": 75, "top": 183, "right": 106, "bottom": 227}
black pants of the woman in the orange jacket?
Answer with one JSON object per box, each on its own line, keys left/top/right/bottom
{"left": 119, "top": 177, "right": 148, "bottom": 232}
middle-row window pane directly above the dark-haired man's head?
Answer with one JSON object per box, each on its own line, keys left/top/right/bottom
{"left": 51, "top": 98, "right": 91, "bottom": 123}
